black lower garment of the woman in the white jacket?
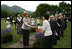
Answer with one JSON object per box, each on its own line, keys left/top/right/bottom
{"left": 43, "top": 35, "right": 53, "bottom": 48}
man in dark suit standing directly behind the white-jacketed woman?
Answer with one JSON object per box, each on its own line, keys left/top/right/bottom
{"left": 49, "top": 16, "right": 59, "bottom": 45}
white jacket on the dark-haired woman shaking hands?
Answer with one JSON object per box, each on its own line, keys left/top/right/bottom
{"left": 41, "top": 20, "right": 52, "bottom": 36}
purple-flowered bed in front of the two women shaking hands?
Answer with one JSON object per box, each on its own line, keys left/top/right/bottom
{"left": 33, "top": 33, "right": 44, "bottom": 48}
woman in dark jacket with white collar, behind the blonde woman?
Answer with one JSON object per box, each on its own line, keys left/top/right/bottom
{"left": 16, "top": 13, "right": 23, "bottom": 42}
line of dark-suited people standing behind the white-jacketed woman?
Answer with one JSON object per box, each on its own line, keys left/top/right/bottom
{"left": 49, "top": 13, "right": 67, "bottom": 45}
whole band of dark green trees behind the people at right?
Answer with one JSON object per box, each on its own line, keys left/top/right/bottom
{"left": 32, "top": 2, "right": 71, "bottom": 18}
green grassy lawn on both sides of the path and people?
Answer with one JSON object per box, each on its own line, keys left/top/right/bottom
{"left": 1, "top": 19, "right": 71, "bottom": 48}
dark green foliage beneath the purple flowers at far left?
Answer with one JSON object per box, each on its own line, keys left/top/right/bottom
{"left": 1, "top": 32, "right": 13, "bottom": 44}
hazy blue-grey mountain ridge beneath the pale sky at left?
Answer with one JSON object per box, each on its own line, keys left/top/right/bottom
{"left": 1, "top": 4, "right": 33, "bottom": 14}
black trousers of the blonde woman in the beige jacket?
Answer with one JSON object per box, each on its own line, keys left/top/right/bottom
{"left": 22, "top": 29, "right": 29, "bottom": 46}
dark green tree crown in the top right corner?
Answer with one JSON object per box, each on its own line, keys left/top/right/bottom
{"left": 59, "top": 2, "right": 71, "bottom": 14}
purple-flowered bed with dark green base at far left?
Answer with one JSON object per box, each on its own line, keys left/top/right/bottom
{"left": 1, "top": 29, "right": 13, "bottom": 44}
